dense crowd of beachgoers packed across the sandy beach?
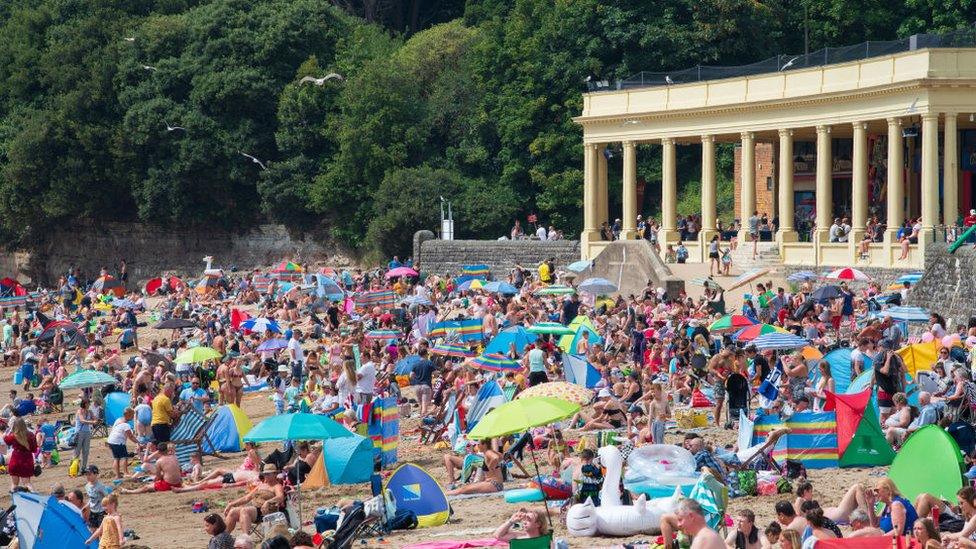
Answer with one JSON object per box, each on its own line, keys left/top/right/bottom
{"left": 0, "top": 245, "right": 976, "bottom": 548}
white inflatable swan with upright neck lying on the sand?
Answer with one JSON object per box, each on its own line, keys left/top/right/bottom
{"left": 566, "top": 446, "right": 681, "bottom": 537}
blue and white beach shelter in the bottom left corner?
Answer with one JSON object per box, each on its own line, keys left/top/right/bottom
{"left": 11, "top": 492, "right": 96, "bottom": 549}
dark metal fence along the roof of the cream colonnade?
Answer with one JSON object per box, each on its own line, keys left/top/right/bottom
{"left": 600, "top": 27, "right": 976, "bottom": 91}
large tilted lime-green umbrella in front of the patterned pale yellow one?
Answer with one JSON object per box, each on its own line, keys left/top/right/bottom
{"left": 468, "top": 397, "right": 580, "bottom": 440}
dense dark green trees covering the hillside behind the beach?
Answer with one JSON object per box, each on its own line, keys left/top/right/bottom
{"left": 0, "top": 0, "right": 976, "bottom": 254}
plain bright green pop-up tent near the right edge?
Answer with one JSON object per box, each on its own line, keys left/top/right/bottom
{"left": 888, "top": 425, "right": 963, "bottom": 501}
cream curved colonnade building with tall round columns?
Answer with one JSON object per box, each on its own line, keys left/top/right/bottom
{"left": 575, "top": 48, "right": 976, "bottom": 268}
